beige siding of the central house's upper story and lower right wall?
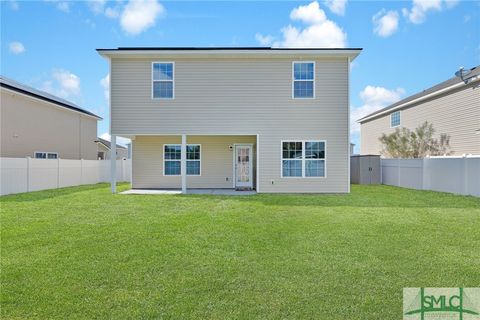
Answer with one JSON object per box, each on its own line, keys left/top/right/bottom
{"left": 111, "top": 57, "right": 349, "bottom": 192}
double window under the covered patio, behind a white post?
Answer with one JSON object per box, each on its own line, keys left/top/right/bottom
{"left": 163, "top": 144, "right": 201, "bottom": 176}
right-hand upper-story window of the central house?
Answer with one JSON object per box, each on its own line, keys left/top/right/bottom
{"left": 292, "top": 62, "right": 315, "bottom": 99}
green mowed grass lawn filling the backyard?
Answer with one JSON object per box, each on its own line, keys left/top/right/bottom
{"left": 0, "top": 184, "right": 480, "bottom": 319}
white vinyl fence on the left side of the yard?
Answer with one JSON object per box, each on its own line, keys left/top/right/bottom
{"left": 0, "top": 158, "right": 131, "bottom": 195}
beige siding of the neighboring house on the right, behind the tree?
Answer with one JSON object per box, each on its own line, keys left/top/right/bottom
{"left": 361, "top": 85, "right": 480, "bottom": 155}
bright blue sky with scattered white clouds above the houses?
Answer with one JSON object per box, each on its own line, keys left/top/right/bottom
{"left": 0, "top": 0, "right": 480, "bottom": 150}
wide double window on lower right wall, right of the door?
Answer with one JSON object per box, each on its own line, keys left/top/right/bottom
{"left": 282, "top": 141, "right": 326, "bottom": 178}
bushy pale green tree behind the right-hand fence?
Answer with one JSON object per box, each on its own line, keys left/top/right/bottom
{"left": 379, "top": 121, "right": 451, "bottom": 158}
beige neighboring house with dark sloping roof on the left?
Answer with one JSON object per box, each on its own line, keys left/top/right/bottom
{"left": 0, "top": 77, "right": 102, "bottom": 160}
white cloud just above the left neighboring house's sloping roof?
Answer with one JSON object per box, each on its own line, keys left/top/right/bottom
{"left": 42, "top": 70, "right": 80, "bottom": 98}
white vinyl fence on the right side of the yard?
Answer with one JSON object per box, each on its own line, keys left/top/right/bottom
{"left": 381, "top": 156, "right": 480, "bottom": 197}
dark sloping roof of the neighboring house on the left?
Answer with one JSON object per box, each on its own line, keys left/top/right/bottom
{"left": 0, "top": 76, "right": 102, "bottom": 119}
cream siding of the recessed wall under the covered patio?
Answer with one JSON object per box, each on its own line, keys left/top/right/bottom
{"left": 132, "top": 136, "right": 257, "bottom": 188}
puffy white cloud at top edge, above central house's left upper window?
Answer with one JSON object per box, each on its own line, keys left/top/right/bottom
{"left": 120, "top": 0, "right": 165, "bottom": 35}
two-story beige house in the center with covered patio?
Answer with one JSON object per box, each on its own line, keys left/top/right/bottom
{"left": 98, "top": 48, "right": 361, "bottom": 193}
